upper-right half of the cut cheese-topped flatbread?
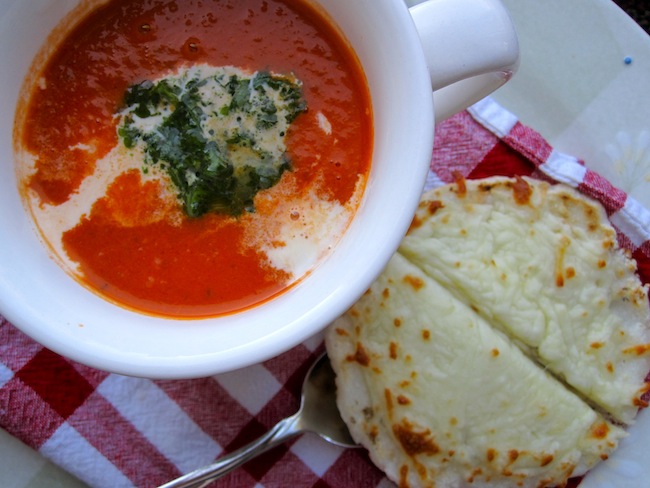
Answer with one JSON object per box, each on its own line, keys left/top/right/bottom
{"left": 400, "top": 179, "right": 650, "bottom": 423}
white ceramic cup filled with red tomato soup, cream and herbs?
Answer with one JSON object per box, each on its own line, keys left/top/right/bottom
{"left": 0, "top": 0, "right": 516, "bottom": 378}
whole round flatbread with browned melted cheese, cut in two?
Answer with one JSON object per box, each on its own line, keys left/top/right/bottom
{"left": 326, "top": 178, "right": 650, "bottom": 488}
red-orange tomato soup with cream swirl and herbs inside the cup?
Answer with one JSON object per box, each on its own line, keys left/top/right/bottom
{"left": 15, "top": 0, "right": 372, "bottom": 318}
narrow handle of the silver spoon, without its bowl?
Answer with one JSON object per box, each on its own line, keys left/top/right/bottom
{"left": 159, "top": 414, "right": 302, "bottom": 488}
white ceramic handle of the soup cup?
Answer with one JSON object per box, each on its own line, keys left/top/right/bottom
{"left": 410, "top": 0, "right": 519, "bottom": 123}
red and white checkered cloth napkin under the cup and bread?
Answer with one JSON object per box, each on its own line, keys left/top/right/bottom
{"left": 0, "top": 99, "right": 650, "bottom": 488}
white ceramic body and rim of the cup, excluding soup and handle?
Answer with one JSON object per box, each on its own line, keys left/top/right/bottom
{"left": 0, "top": 0, "right": 516, "bottom": 378}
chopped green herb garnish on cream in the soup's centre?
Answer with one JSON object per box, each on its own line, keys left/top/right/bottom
{"left": 118, "top": 68, "right": 306, "bottom": 217}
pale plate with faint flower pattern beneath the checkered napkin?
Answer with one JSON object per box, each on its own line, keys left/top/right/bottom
{"left": 0, "top": 0, "right": 650, "bottom": 488}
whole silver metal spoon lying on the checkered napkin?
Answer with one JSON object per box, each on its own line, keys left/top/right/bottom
{"left": 159, "top": 354, "right": 359, "bottom": 488}
